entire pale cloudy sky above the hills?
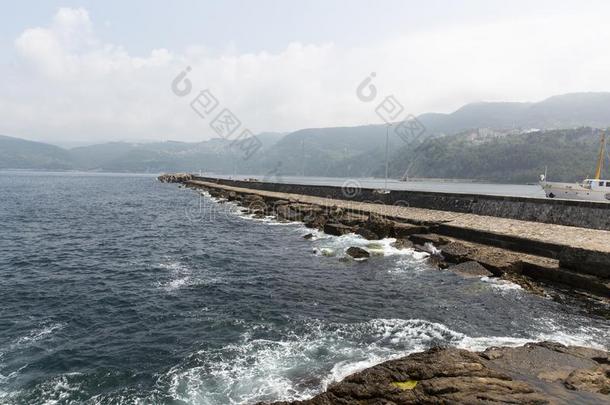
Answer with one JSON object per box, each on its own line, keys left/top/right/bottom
{"left": 0, "top": 0, "right": 610, "bottom": 145}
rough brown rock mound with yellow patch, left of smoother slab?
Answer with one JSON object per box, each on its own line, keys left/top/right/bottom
{"left": 266, "top": 348, "right": 547, "bottom": 405}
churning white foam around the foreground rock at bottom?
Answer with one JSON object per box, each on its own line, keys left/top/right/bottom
{"left": 160, "top": 319, "right": 604, "bottom": 404}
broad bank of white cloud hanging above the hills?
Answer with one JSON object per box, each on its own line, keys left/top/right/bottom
{"left": 0, "top": 8, "right": 610, "bottom": 141}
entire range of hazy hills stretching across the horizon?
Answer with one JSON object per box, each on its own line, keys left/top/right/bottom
{"left": 0, "top": 93, "right": 610, "bottom": 182}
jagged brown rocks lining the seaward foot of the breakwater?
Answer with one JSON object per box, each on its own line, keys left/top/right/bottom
{"left": 175, "top": 174, "right": 584, "bottom": 295}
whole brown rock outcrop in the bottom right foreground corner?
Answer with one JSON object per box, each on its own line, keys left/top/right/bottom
{"left": 260, "top": 342, "right": 610, "bottom": 405}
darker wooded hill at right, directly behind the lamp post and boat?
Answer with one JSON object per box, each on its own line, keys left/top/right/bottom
{"left": 390, "top": 128, "right": 600, "bottom": 183}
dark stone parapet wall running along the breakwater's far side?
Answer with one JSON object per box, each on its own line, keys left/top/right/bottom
{"left": 194, "top": 176, "right": 610, "bottom": 230}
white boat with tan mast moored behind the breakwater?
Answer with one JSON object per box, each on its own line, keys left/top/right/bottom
{"left": 539, "top": 131, "right": 610, "bottom": 202}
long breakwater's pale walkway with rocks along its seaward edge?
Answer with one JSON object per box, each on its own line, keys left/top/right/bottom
{"left": 169, "top": 176, "right": 610, "bottom": 297}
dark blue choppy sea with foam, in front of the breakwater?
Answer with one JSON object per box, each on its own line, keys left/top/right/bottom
{"left": 0, "top": 172, "right": 609, "bottom": 404}
